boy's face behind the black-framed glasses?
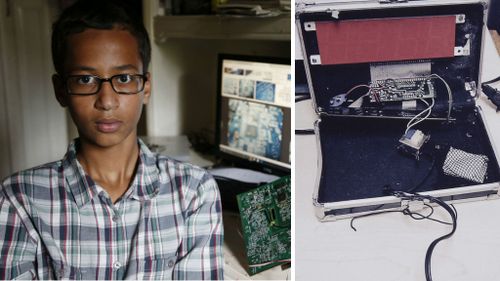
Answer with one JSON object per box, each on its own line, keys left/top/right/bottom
{"left": 53, "top": 28, "right": 150, "bottom": 147}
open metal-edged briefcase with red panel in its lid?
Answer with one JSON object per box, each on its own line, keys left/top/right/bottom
{"left": 296, "top": 0, "right": 500, "bottom": 220}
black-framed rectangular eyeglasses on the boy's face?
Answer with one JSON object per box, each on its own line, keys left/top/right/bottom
{"left": 66, "top": 74, "right": 148, "bottom": 96}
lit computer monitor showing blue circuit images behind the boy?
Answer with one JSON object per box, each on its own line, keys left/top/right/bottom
{"left": 216, "top": 54, "right": 292, "bottom": 174}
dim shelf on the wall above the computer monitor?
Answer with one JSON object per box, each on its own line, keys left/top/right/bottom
{"left": 154, "top": 14, "right": 291, "bottom": 43}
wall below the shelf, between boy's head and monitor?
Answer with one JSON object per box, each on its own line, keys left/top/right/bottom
{"left": 143, "top": 0, "right": 291, "bottom": 139}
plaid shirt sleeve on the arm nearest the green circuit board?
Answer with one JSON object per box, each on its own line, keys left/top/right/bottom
{"left": 173, "top": 172, "right": 223, "bottom": 280}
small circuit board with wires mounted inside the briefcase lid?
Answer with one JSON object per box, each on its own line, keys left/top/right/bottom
{"left": 369, "top": 77, "right": 436, "bottom": 102}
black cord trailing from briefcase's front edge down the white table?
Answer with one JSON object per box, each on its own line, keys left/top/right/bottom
{"left": 351, "top": 191, "right": 458, "bottom": 281}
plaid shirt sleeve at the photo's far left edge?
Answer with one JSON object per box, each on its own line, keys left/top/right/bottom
{"left": 0, "top": 188, "right": 37, "bottom": 280}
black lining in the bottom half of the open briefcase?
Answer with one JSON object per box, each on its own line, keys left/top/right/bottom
{"left": 318, "top": 110, "right": 500, "bottom": 203}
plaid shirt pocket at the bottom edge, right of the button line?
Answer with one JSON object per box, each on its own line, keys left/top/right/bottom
{"left": 126, "top": 255, "right": 177, "bottom": 280}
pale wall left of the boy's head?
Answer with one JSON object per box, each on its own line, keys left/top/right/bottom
{"left": 0, "top": 0, "right": 68, "bottom": 177}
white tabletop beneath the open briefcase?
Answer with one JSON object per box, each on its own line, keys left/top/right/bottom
{"left": 294, "top": 33, "right": 500, "bottom": 281}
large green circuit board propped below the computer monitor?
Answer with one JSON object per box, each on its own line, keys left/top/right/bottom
{"left": 237, "top": 176, "right": 292, "bottom": 275}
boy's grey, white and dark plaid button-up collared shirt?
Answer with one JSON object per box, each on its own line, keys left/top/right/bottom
{"left": 0, "top": 140, "right": 223, "bottom": 280}
